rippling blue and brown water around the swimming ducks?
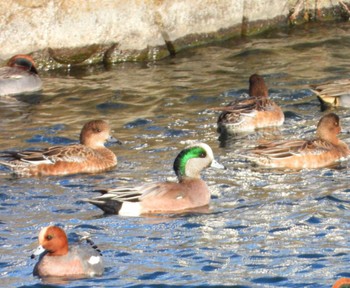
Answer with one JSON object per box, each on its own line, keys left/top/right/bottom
{"left": 0, "top": 23, "right": 350, "bottom": 287}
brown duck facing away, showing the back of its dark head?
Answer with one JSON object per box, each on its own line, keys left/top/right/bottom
{"left": 211, "top": 74, "right": 284, "bottom": 133}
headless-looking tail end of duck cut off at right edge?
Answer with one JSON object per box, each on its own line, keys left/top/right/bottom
{"left": 311, "top": 79, "right": 350, "bottom": 107}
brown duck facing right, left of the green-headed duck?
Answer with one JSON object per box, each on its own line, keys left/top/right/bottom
{"left": 0, "top": 120, "right": 120, "bottom": 176}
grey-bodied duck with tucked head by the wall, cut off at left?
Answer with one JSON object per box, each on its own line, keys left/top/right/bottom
{"left": 0, "top": 55, "right": 42, "bottom": 96}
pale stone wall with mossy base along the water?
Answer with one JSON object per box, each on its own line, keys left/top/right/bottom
{"left": 0, "top": 0, "right": 346, "bottom": 68}
